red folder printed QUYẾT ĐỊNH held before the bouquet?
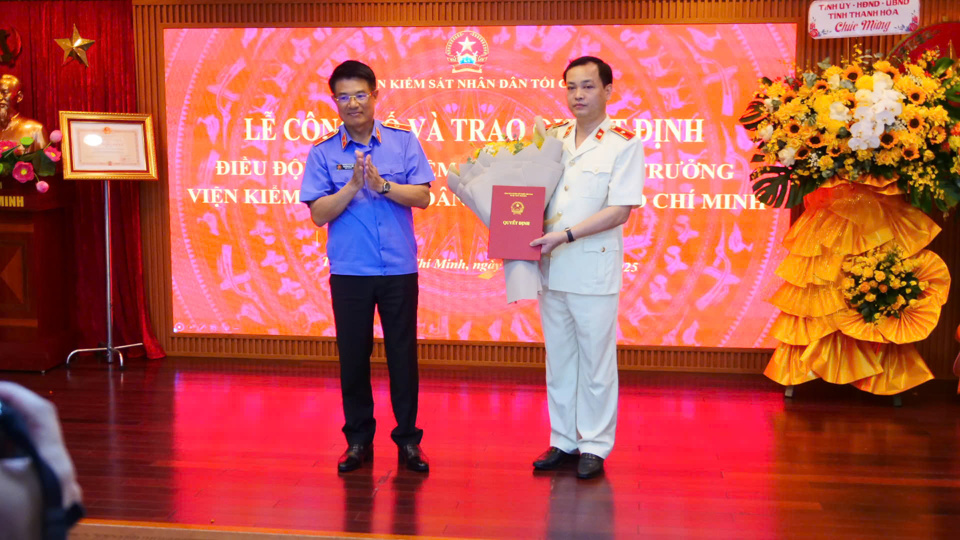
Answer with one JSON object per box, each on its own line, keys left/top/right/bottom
{"left": 488, "top": 186, "right": 547, "bottom": 261}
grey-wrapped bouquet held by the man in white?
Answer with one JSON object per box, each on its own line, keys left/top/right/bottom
{"left": 447, "top": 117, "right": 563, "bottom": 303}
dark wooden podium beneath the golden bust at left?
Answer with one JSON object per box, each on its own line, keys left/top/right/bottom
{"left": 0, "top": 177, "right": 75, "bottom": 372}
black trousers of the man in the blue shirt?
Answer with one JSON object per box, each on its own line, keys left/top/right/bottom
{"left": 330, "top": 274, "right": 423, "bottom": 446}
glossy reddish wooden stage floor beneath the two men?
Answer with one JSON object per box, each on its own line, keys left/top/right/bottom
{"left": 0, "top": 357, "right": 960, "bottom": 539}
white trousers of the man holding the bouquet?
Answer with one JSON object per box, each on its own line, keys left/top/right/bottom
{"left": 540, "top": 289, "right": 620, "bottom": 459}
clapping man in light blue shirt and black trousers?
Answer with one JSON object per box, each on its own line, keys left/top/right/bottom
{"left": 300, "top": 60, "right": 434, "bottom": 472}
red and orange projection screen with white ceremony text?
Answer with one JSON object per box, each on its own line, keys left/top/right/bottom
{"left": 163, "top": 24, "right": 796, "bottom": 348}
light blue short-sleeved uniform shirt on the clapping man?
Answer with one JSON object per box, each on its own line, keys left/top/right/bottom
{"left": 300, "top": 120, "right": 434, "bottom": 276}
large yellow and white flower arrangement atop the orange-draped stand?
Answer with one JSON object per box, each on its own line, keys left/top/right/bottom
{"left": 740, "top": 50, "right": 960, "bottom": 213}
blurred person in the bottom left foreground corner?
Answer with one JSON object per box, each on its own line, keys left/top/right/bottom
{"left": 0, "top": 381, "right": 83, "bottom": 540}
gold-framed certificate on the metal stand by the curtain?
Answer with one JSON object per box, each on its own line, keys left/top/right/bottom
{"left": 60, "top": 111, "right": 157, "bottom": 180}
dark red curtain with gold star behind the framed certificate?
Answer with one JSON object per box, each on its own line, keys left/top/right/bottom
{"left": 0, "top": 0, "right": 164, "bottom": 359}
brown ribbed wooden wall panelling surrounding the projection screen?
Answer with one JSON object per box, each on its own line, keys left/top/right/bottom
{"left": 133, "top": 0, "right": 960, "bottom": 377}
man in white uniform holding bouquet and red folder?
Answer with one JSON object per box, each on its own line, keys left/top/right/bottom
{"left": 530, "top": 56, "right": 644, "bottom": 478}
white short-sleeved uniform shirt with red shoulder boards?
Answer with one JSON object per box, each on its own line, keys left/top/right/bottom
{"left": 540, "top": 117, "right": 644, "bottom": 294}
